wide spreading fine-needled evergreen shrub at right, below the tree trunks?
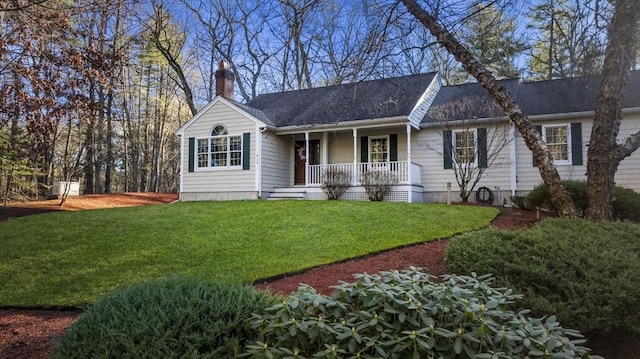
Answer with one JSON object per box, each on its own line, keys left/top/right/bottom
{"left": 446, "top": 219, "right": 640, "bottom": 333}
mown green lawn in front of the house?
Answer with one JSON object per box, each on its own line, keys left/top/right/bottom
{"left": 0, "top": 201, "right": 497, "bottom": 307}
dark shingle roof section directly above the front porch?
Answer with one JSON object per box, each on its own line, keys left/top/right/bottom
{"left": 242, "top": 72, "right": 436, "bottom": 127}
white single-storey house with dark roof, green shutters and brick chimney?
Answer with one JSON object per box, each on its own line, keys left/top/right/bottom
{"left": 176, "top": 62, "right": 640, "bottom": 203}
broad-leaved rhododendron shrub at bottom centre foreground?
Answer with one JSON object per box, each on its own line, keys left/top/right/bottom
{"left": 243, "top": 268, "right": 588, "bottom": 358}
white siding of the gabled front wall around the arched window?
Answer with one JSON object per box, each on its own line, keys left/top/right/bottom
{"left": 181, "top": 102, "right": 257, "bottom": 200}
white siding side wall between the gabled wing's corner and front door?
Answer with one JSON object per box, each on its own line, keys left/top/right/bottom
{"left": 262, "top": 131, "right": 292, "bottom": 196}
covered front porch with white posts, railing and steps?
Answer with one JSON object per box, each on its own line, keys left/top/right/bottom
{"left": 268, "top": 123, "right": 423, "bottom": 202}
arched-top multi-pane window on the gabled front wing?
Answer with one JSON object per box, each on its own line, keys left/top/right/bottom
{"left": 197, "top": 126, "right": 242, "bottom": 168}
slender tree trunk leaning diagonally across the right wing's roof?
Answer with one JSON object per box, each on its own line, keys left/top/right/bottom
{"left": 402, "top": 0, "right": 577, "bottom": 217}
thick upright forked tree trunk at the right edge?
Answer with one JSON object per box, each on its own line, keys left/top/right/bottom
{"left": 587, "top": 0, "right": 640, "bottom": 221}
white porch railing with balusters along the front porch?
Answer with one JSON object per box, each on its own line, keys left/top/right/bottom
{"left": 307, "top": 161, "right": 421, "bottom": 185}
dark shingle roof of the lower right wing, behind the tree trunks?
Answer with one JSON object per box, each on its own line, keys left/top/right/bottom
{"left": 422, "top": 71, "right": 640, "bottom": 125}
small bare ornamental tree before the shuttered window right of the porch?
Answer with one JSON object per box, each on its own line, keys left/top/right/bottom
{"left": 425, "top": 97, "right": 510, "bottom": 202}
